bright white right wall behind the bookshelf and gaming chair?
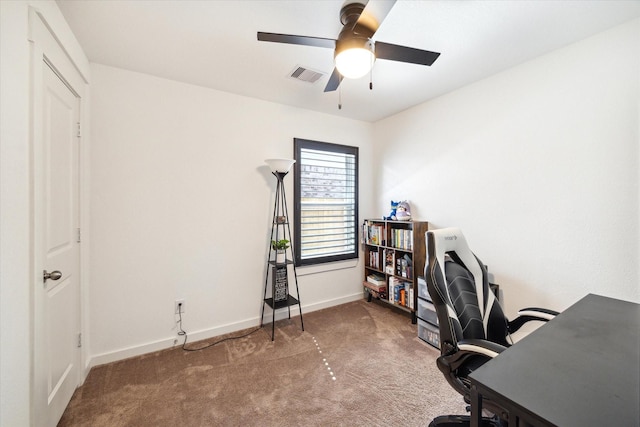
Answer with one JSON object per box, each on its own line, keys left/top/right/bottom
{"left": 375, "top": 20, "right": 640, "bottom": 316}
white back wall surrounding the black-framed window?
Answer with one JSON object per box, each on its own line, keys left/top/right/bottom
{"left": 89, "top": 64, "right": 372, "bottom": 364}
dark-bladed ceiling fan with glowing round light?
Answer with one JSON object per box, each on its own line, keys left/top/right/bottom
{"left": 258, "top": 0, "right": 440, "bottom": 92}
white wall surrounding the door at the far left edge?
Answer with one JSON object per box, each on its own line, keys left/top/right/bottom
{"left": 0, "top": 0, "right": 88, "bottom": 426}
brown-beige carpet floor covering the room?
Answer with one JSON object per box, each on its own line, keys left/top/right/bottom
{"left": 59, "top": 300, "right": 465, "bottom": 427}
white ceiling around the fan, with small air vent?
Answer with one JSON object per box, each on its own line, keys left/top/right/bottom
{"left": 57, "top": 0, "right": 640, "bottom": 122}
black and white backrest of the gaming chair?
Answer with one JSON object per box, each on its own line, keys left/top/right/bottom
{"left": 425, "top": 228, "right": 508, "bottom": 352}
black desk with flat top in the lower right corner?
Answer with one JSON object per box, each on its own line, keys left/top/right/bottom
{"left": 471, "top": 294, "right": 640, "bottom": 427}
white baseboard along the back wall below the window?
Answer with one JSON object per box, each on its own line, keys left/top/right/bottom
{"left": 85, "top": 292, "right": 363, "bottom": 376}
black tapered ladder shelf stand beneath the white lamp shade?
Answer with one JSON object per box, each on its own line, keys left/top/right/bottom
{"left": 260, "top": 172, "right": 304, "bottom": 341}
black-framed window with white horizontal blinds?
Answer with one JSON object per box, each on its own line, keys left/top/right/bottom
{"left": 294, "top": 138, "right": 358, "bottom": 265}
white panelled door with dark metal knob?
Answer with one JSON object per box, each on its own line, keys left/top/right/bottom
{"left": 33, "top": 10, "right": 81, "bottom": 426}
